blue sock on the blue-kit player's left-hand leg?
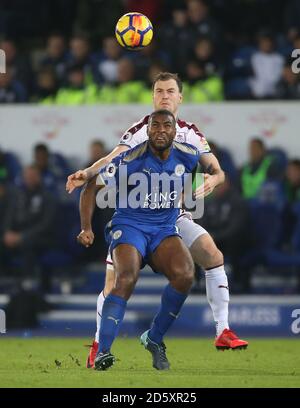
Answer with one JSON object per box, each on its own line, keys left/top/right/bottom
{"left": 98, "top": 295, "right": 127, "bottom": 353}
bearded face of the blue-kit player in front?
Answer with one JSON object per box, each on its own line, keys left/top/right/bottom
{"left": 148, "top": 115, "right": 176, "bottom": 151}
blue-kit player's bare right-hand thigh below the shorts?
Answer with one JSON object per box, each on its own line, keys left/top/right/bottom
{"left": 151, "top": 236, "right": 194, "bottom": 279}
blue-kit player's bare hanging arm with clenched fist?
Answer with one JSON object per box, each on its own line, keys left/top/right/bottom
{"left": 77, "top": 176, "right": 101, "bottom": 248}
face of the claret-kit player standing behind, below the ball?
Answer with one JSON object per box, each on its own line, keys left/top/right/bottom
{"left": 153, "top": 79, "right": 182, "bottom": 117}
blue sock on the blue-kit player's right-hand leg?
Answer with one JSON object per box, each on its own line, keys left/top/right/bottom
{"left": 148, "top": 284, "right": 187, "bottom": 344}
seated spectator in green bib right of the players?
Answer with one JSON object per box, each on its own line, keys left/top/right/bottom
{"left": 240, "top": 138, "right": 276, "bottom": 199}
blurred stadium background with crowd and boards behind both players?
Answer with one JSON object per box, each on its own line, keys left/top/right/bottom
{"left": 0, "top": 0, "right": 300, "bottom": 337}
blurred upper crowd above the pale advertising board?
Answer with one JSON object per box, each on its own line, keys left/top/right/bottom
{"left": 0, "top": 0, "right": 300, "bottom": 105}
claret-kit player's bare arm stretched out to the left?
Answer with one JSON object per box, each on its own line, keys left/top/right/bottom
{"left": 66, "top": 145, "right": 129, "bottom": 194}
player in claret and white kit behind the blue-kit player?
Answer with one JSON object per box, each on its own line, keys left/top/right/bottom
{"left": 71, "top": 72, "right": 248, "bottom": 367}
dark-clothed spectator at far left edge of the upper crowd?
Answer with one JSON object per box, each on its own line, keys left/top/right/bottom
{"left": 0, "top": 39, "right": 33, "bottom": 93}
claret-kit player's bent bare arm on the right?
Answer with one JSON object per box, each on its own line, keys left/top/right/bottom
{"left": 195, "top": 153, "right": 225, "bottom": 198}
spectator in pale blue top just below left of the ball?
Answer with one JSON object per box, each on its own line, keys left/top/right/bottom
{"left": 93, "top": 36, "right": 123, "bottom": 84}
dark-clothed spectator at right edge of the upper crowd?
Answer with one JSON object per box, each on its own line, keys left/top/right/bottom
{"left": 277, "top": 60, "right": 300, "bottom": 99}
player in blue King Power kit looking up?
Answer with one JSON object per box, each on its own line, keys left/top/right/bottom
{"left": 80, "top": 110, "right": 199, "bottom": 370}
